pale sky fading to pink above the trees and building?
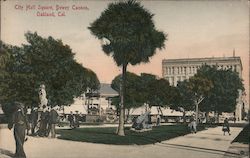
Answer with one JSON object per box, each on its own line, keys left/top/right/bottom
{"left": 1, "top": 0, "right": 249, "bottom": 103}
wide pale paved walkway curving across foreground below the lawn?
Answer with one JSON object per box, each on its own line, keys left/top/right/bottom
{"left": 0, "top": 127, "right": 246, "bottom": 158}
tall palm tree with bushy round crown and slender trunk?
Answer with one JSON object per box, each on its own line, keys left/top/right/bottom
{"left": 88, "top": 0, "right": 166, "bottom": 136}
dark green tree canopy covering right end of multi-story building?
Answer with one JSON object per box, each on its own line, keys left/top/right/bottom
{"left": 197, "top": 65, "right": 244, "bottom": 113}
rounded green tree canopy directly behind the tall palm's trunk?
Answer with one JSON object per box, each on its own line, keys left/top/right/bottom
{"left": 111, "top": 72, "right": 175, "bottom": 113}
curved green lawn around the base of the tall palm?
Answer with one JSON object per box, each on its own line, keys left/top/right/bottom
{"left": 57, "top": 125, "right": 211, "bottom": 145}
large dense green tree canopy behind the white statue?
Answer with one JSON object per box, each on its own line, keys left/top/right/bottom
{"left": 0, "top": 32, "right": 100, "bottom": 116}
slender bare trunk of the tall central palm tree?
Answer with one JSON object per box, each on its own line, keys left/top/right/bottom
{"left": 117, "top": 64, "right": 127, "bottom": 136}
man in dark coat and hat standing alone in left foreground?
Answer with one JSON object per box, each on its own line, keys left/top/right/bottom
{"left": 8, "top": 102, "right": 30, "bottom": 158}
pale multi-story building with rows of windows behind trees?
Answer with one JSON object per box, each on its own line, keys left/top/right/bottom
{"left": 162, "top": 56, "right": 243, "bottom": 120}
